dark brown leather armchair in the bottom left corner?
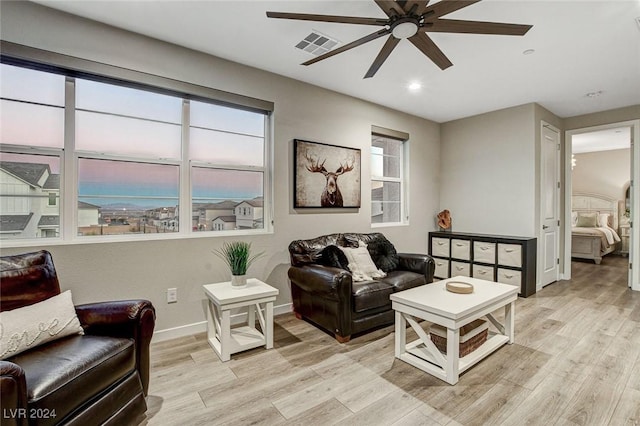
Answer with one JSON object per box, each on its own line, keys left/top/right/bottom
{"left": 0, "top": 250, "right": 155, "bottom": 426}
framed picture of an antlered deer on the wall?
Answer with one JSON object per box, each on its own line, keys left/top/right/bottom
{"left": 293, "top": 139, "right": 361, "bottom": 208}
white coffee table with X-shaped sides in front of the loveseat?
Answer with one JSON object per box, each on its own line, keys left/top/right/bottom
{"left": 391, "top": 277, "right": 519, "bottom": 385}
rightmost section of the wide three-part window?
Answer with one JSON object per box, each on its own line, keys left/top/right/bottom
{"left": 189, "top": 101, "right": 265, "bottom": 231}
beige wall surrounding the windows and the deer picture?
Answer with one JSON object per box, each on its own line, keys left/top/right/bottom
{"left": 0, "top": 2, "right": 440, "bottom": 336}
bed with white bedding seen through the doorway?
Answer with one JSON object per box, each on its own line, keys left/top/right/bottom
{"left": 571, "top": 194, "right": 620, "bottom": 265}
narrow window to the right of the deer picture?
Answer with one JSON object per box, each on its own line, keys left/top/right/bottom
{"left": 371, "top": 132, "right": 406, "bottom": 224}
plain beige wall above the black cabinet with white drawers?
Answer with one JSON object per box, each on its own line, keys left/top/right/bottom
{"left": 440, "top": 104, "right": 537, "bottom": 237}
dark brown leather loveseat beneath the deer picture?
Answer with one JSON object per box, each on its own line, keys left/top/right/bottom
{"left": 289, "top": 233, "right": 435, "bottom": 343}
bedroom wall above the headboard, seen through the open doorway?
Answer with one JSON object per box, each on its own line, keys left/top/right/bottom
{"left": 571, "top": 148, "right": 631, "bottom": 200}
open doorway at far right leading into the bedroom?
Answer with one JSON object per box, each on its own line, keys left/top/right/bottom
{"left": 564, "top": 120, "right": 640, "bottom": 290}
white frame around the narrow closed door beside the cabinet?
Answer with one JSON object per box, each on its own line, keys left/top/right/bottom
{"left": 536, "top": 120, "right": 563, "bottom": 290}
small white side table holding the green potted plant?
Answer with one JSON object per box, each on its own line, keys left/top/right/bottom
{"left": 202, "top": 278, "right": 279, "bottom": 361}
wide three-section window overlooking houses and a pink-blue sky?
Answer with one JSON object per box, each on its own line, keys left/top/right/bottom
{"left": 0, "top": 58, "right": 269, "bottom": 240}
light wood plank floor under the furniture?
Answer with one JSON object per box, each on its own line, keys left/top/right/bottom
{"left": 144, "top": 256, "right": 640, "bottom": 426}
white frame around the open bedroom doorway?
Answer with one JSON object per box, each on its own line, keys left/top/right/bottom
{"left": 561, "top": 120, "right": 640, "bottom": 291}
